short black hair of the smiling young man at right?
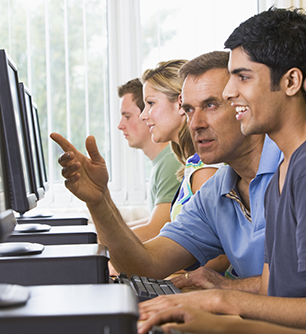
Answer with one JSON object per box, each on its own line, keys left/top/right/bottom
{"left": 224, "top": 7, "right": 306, "bottom": 98}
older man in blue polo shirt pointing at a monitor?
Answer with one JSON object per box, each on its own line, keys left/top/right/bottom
{"left": 51, "top": 51, "right": 280, "bottom": 291}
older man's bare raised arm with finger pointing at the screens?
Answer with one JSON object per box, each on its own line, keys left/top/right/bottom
{"left": 51, "top": 133, "right": 195, "bottom": 278}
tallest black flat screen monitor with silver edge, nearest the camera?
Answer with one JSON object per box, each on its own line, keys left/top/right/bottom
{"left": 0, "top": 50, "right": 37, "bottom": 214}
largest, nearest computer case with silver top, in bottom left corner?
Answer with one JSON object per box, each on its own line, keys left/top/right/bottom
{"left": 0, "top": 284, "right": 138, "bottom": 334}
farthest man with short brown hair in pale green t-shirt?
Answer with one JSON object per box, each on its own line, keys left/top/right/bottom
{"left": 118, "top": 78, "right": 180, "bottom": 241}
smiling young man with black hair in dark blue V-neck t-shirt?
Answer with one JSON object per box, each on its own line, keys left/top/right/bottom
{"left": 224, "top": 8, "right": 306, "bottom": 297}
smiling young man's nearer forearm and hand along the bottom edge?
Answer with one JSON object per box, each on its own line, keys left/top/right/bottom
{"left": 138, "top": 306, "right": 306, "bottom": 334}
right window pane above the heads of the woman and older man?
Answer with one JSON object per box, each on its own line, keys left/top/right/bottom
{"left": 140, "top": 0, "right": 257, "bottom": 71}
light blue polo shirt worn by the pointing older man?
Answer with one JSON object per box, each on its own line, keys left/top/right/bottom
{"left": 159, "top": 136, "right": 281, "bottom": 278}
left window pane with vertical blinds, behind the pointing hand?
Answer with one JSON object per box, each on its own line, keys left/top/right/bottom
{"left": 0, "top": 0, "right": 111, "bottom": 210}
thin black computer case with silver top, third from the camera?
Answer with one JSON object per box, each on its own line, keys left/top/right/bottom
{"left": 7, "top": 224, "right": 97, "bottom": 245}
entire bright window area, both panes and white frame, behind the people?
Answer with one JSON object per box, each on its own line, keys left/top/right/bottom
{"left": 0, "top": 0, "right": 296, "bottom": 213}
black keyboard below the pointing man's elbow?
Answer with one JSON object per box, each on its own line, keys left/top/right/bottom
{"left": 114, "top": 274, "right": 182, "bottom": 302}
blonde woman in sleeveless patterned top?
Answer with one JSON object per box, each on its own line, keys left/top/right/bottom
{"left": 140, "top": 60, "right": 229, "bottom": 272}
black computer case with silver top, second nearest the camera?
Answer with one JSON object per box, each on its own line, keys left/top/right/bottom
{"left": 0, "top": 244, "right": 109, "bottom": 285}
